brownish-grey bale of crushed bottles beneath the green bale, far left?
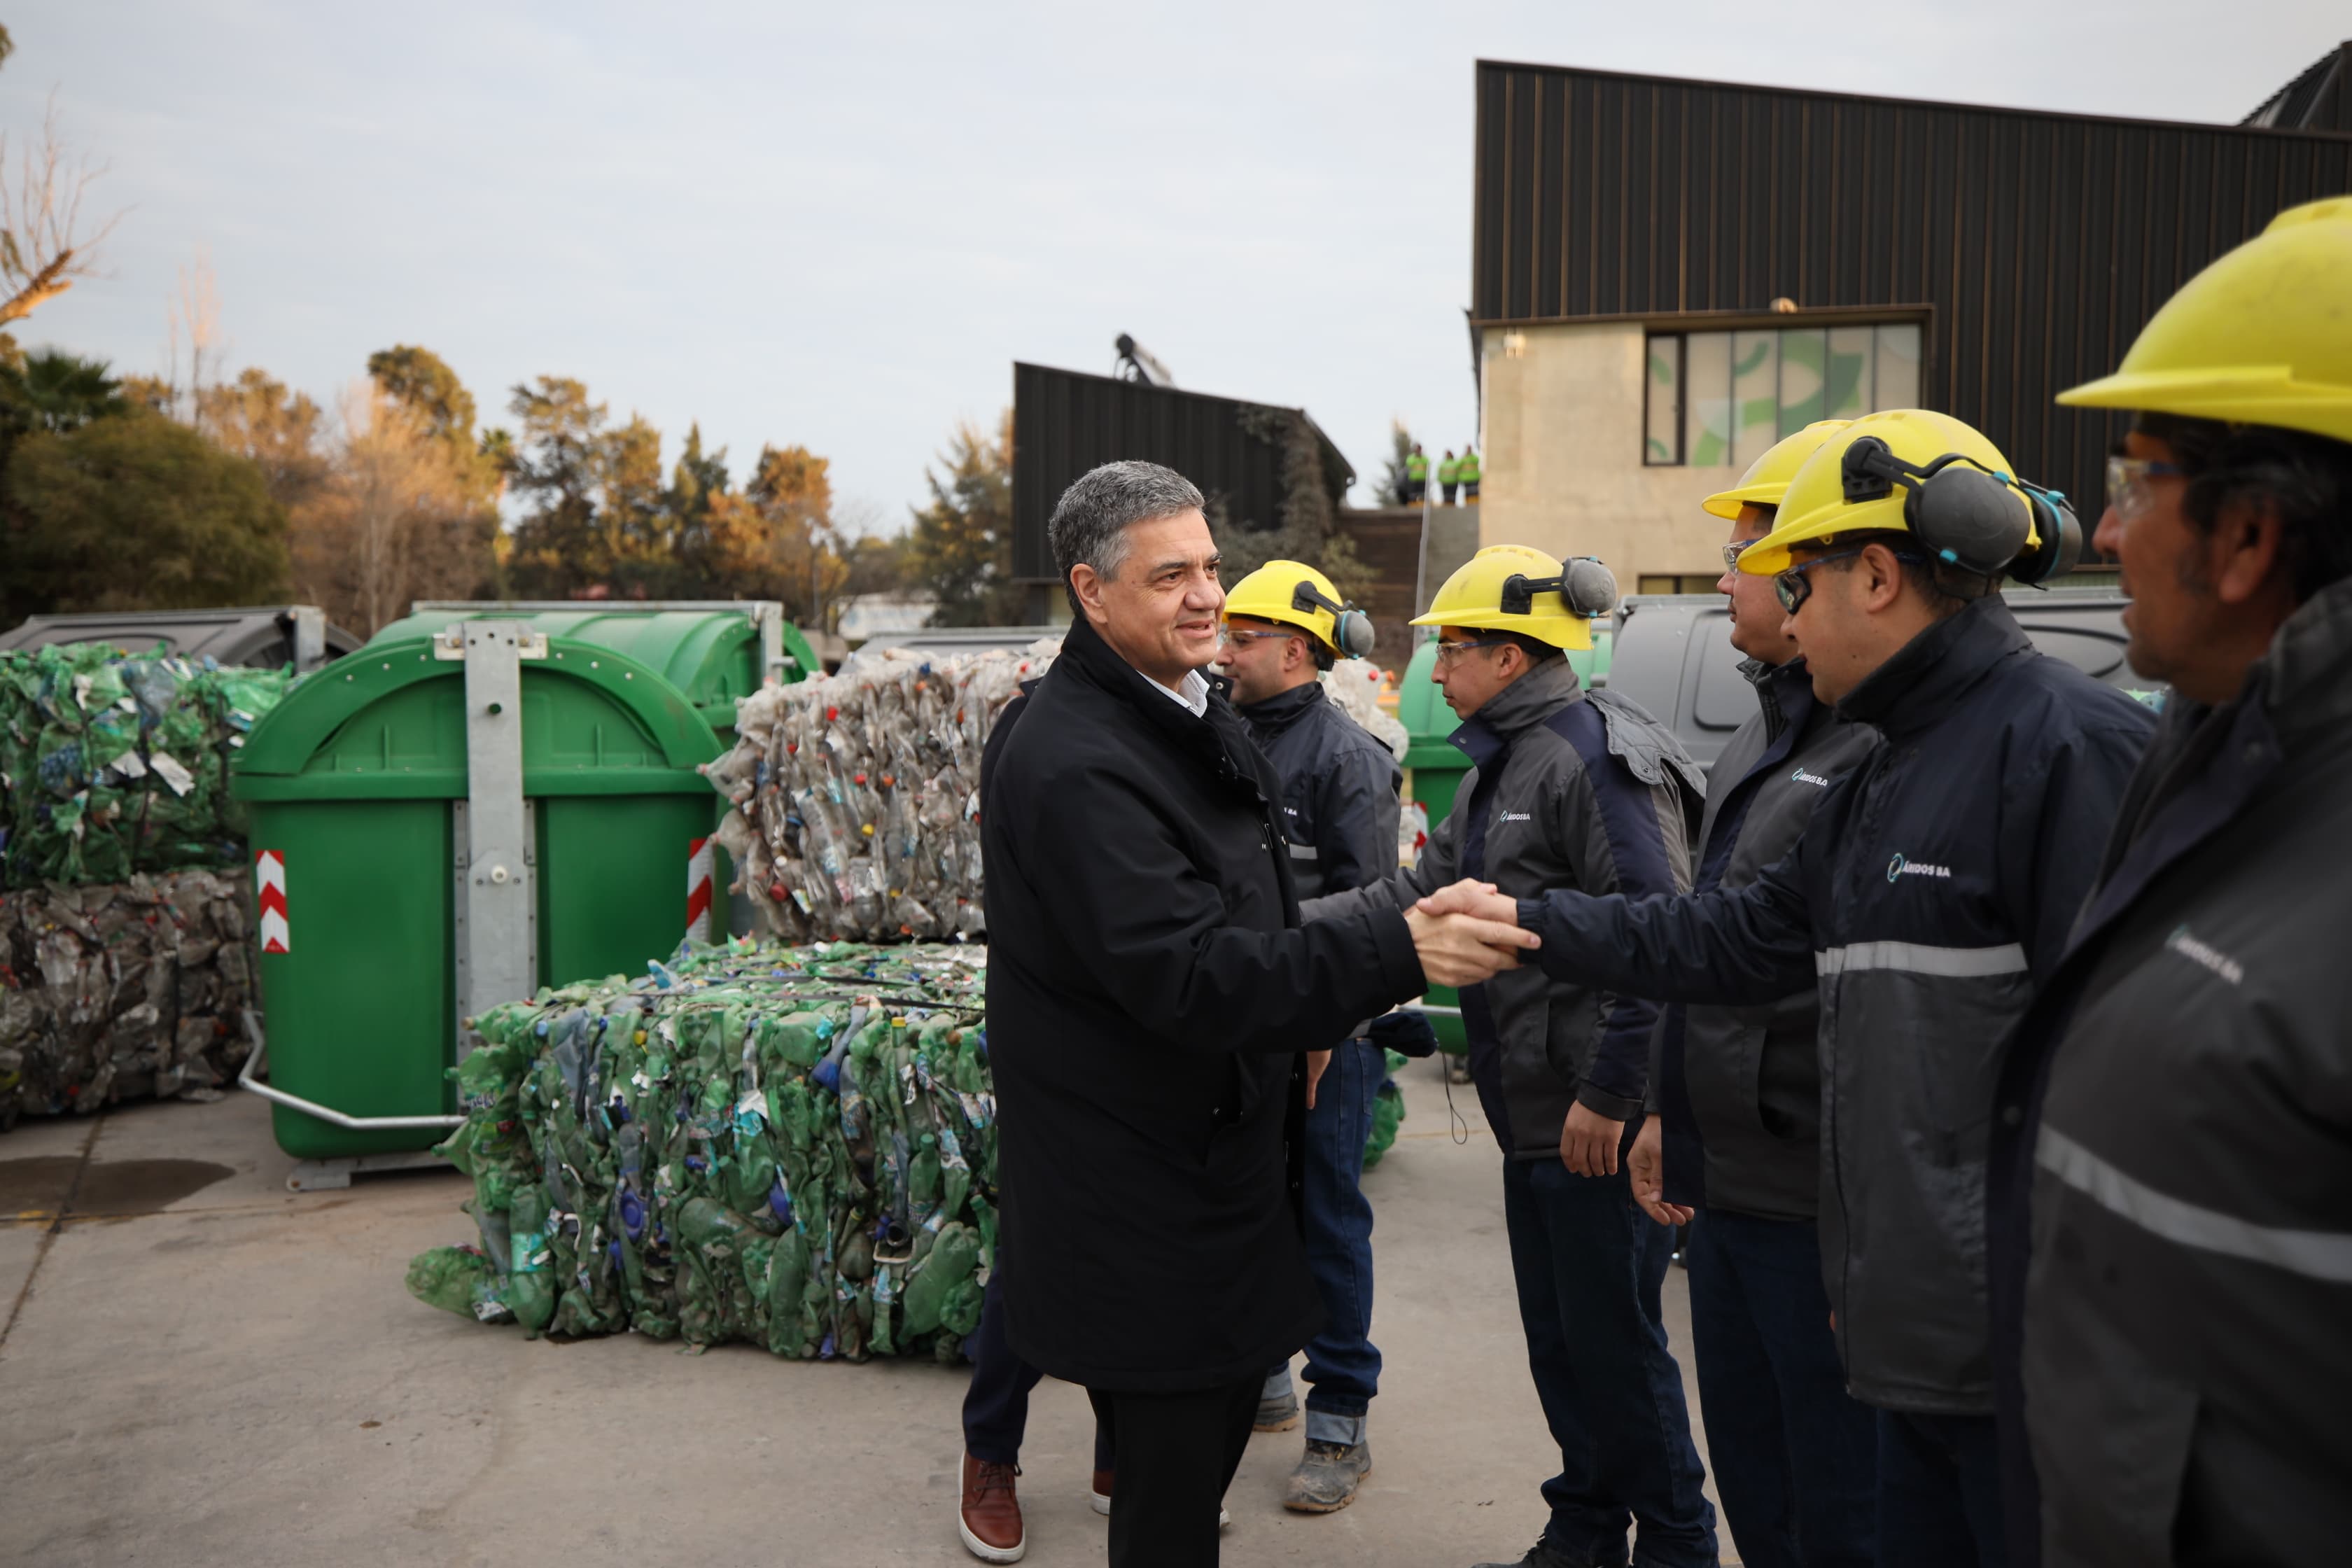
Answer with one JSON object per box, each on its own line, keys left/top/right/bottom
{"left": 0, "top": 870, "right": 254, "bottom": 1128}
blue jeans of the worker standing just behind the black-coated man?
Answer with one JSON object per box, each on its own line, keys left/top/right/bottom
{"left": 1261, "top": 1039, "right": 1387, "bottom": 1443}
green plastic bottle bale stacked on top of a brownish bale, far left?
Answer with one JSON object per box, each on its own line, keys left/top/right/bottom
{"left": 0, "top": 642, "right": 294, "bottom": 886}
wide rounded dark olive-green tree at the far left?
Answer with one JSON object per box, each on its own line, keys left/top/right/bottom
{"left": 0, "top": 409, "right": 287, "bottom": 616}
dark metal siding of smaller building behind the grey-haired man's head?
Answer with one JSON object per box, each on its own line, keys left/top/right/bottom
{"left": 1014, "top": 365, "right": 1345, "bottom": 581}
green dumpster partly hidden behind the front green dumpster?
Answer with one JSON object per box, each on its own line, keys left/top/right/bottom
{"left": 374, "top": 599, "right": 823, "bottom": 936}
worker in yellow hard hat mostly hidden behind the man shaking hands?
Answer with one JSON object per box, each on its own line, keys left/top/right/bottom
{"left": 1630, "top": 419, "right": 1877, "bottom": 1563}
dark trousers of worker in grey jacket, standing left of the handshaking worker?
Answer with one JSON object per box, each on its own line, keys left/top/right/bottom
{"left": 1503, "top": 1147, "right": 1714, "bottom": 1568}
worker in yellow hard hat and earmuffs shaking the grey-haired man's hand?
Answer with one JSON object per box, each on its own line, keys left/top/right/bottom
{"left": 1423, "top": 409, "right": 2152, "bottom": 1568}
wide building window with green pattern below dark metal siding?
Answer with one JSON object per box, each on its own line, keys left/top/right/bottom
{"left": 1642, "top": 322, "right": 1919, "bottom": 468}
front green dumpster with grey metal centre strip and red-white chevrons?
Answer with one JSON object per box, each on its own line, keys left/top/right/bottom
{"left": 230, "top": 621, "right": 720, "bottom": 1161}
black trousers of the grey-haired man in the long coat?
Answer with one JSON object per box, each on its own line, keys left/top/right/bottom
{"left": 1086, "top": 1378, "right": 1263, "bottom": 1568}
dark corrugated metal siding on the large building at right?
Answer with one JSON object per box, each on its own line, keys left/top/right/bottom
{"left": 1470, "top": 61, "right": 2352, "bottom": 526}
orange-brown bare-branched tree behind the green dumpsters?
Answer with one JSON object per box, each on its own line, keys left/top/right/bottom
{"left": 292, "top": 386, "right": 498, "bottom": 635}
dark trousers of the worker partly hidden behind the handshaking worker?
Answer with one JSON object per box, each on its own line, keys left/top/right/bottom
{"left": 1684, "top": 1208, "right": 1879, "bottom": 1568}
